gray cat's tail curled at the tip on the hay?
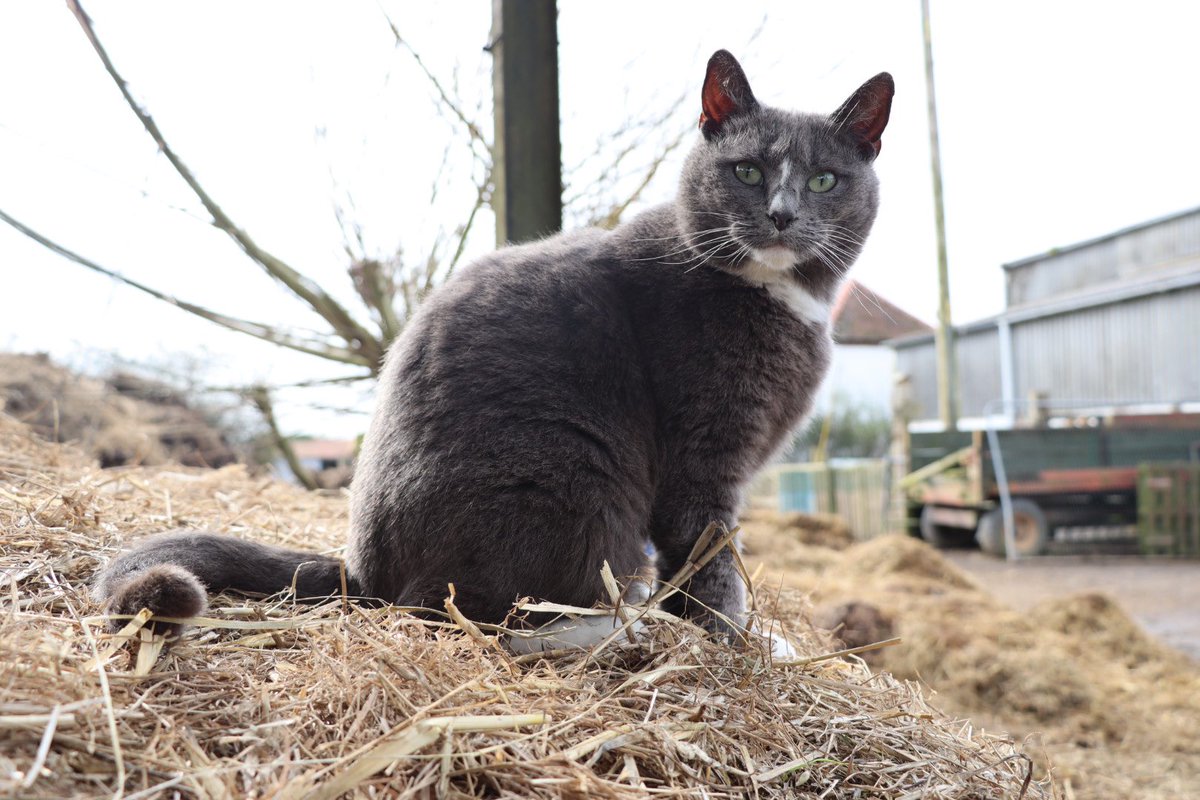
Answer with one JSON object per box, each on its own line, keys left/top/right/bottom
{"left": 91, "top": 530, "right": 360, "bottom": 634}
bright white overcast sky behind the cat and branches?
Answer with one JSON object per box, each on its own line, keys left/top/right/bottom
{"left": 0, "top": 0, "right": 1200, "bottom": 435}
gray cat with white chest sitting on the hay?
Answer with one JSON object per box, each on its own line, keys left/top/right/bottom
{"left": 95, "top": 50, "right": 894, "bottom": 632}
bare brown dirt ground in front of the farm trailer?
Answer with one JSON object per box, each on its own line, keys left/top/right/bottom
{"left": 943, "top": 551, "right": 1200, "bottom": 661}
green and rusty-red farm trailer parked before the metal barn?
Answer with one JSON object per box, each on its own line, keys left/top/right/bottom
{"left": 899, "top": 414, "right": 1200, "bottom": 557}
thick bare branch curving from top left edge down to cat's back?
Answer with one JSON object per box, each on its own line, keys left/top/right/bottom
{"left": 67, "top": 0, "right": 383, "bottom": 361}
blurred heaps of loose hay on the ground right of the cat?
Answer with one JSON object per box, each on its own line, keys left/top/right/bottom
{"left": 746, "top": 515, "right": 1200, "bottom": 800}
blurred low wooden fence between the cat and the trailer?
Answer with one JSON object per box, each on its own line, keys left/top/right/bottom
{"left": 750, "top": 458, "right": 890, "bottom": 540}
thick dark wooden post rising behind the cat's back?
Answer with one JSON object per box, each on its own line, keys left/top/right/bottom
{"left": 492, "top": 0, "right": 563, "bottom": 245}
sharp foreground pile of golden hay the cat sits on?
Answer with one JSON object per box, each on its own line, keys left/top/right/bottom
{"left": 0, "top": 416, "right": 1046, "bottom": 799}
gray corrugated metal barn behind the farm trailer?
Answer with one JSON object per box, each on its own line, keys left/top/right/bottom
{"left": 889, "top": 209, "right": 1200, "bottom": 428}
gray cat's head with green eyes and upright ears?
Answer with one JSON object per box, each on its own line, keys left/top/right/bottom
{"left": 677, "top": 50, "right": 894, "bottom": 301}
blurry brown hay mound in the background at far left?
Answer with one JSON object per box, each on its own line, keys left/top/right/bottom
{"left": 0, "top": 353, "right": 238, "bottom": 467}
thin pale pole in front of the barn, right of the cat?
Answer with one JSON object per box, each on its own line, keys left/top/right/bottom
{"left": 920, "top": 0, "right": 959, "bottom": 431}
